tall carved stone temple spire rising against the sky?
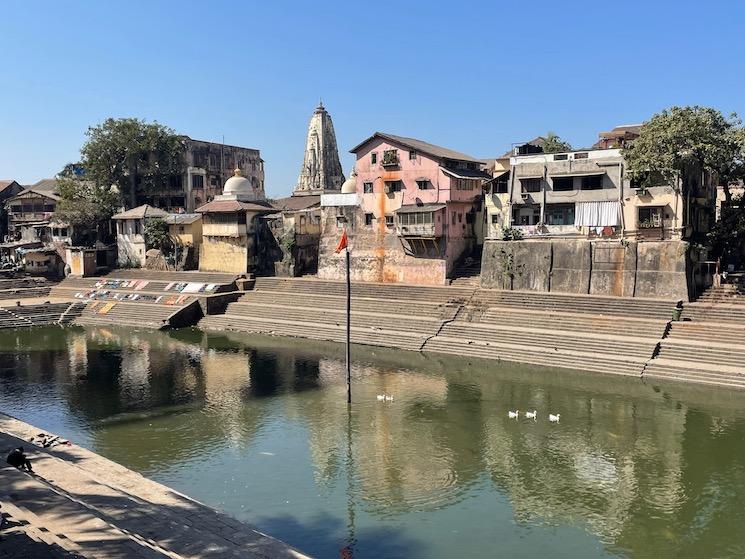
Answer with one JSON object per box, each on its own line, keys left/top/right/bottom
{"left": 293, "top": 103, "right": 344, "bottom": 196}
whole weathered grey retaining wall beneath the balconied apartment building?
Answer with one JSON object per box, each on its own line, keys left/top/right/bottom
{"left": 481, "top": 240, "right": 690, "bottom": 301}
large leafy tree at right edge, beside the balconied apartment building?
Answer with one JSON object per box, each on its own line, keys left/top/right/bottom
{"left": 623, "top": 106, "right": 745, "bottom": 203}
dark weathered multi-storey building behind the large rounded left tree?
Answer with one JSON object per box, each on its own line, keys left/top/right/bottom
{"left": 138, "top": 136, "right": 264, "bottom": 213}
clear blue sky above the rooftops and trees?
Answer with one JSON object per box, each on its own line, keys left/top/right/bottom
{"left": 0, "top": 0, "right": 745, "bottom": 196}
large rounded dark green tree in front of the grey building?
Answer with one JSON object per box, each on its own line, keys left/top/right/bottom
{"left": 80, "top": 118, "right": 184, "bottom": 208}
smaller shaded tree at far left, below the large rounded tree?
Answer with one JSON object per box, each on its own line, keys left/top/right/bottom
{"left": 54, "top": 164, "right": 119, "bottom": 246}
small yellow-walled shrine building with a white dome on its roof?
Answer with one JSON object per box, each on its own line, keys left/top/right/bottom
{"left": 197, "top": 168, "right": 274, "bottom": 274}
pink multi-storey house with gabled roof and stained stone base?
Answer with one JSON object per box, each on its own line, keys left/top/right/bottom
{"left": 319, "top": 132, "right": 489, "bottom": 284}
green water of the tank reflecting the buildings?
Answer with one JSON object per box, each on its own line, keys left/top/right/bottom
{"left": 0, "top": 328, "right": 745, "bottom": 559}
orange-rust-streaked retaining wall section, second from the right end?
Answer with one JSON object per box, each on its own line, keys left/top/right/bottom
{"left": 588, "top": 241, "right": 637, "bottom": 297}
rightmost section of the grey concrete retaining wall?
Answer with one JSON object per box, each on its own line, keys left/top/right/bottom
{"left": 635, "top": 241, "right": 689, "bottom": 301}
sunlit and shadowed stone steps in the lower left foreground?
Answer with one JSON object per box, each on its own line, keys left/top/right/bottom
{"left": 0, "top": 414, "right": 306, "bottom": 559}
